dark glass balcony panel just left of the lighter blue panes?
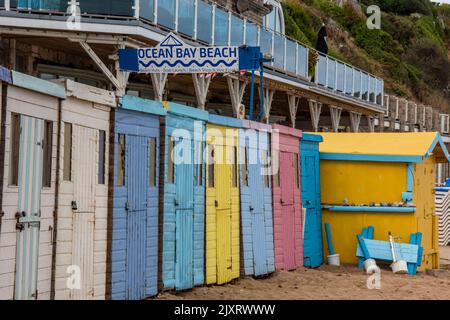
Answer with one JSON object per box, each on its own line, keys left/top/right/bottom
{"left": 78, "top": 0, "right": 134, "bottom": 17}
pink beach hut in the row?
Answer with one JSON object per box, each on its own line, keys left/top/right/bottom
{"left": 272, "top": 124, "right": 303, "bottom": 270}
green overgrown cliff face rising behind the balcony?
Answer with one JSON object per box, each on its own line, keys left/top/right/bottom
{"left": 283, "top": 0, "right": 450, "bottom": 112}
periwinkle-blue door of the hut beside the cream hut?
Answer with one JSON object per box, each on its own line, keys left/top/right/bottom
{"left": 125, "top": 135, "right": 150, "bottom": 300}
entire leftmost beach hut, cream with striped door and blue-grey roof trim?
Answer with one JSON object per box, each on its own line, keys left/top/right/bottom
{"left": 0, "top": 69, "right": 66, "bottom": 300}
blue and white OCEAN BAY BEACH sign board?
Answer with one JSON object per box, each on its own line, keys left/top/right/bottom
{"left": 119, "top": 33, "right": 259, "bottom": 73}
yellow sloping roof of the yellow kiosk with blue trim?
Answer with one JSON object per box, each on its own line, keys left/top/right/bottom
{"left": 312, "top": 132, "right": 450, "bottom": 162}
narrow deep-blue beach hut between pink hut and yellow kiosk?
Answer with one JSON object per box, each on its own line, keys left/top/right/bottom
{"left": 300, "top": 133, "right": 323, "bottom": 268}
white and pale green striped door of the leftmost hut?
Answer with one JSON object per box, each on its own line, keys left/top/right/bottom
{"left": 14, "top": 116, "right": 44, "bottom": 300}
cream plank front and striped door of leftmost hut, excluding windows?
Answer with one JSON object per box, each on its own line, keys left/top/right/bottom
{"left": 0, "top": 85, "right": 58, "bottom": 300}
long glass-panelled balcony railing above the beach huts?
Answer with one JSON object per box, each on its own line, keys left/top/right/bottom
{"left": 0, "top": 0, "right": 384, "bottom": 107}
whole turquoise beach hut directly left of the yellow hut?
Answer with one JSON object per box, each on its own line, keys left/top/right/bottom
{"left": 160, "top": 103, "right": 208, "bottom": 290}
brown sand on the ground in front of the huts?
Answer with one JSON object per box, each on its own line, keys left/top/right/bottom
{"left": 156, "top": 247, "right": 450, "bottom": 300}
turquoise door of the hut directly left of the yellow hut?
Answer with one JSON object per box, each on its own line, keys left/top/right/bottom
{"left": 173, "top": 138, "right": 194, "bottom": 290}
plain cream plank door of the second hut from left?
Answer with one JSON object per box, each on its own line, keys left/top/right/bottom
{"left": 71, "top": 125, "right": 98, "bottom": 300}
